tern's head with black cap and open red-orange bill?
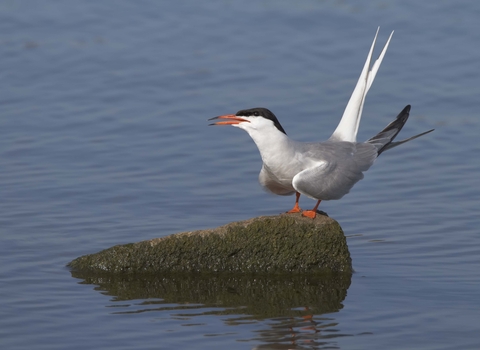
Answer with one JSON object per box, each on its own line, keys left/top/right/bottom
{"left": 209, "top": 108, "right": 287, "bottom": 135}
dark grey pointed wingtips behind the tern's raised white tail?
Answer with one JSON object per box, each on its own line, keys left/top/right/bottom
{"left": 367, "top": 105, "right": 434, "bottom": 155}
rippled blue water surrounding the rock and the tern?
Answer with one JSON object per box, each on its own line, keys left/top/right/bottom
{"left": 0, "top": 0, "right": 480, "bottom": 349}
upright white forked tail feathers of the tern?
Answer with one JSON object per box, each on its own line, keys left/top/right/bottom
{"left": 330, "top": 27, "right": 393, "bottom": 142}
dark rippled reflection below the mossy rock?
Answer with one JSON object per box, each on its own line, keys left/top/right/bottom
{"left": 72, "top": 272, "right": 351, "bottom": 349}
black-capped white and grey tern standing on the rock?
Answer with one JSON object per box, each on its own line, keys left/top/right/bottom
{"left": 208, "top": 28, "right": 434, "bottom": 219}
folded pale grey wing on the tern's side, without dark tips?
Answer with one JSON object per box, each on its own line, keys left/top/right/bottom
{"left": 292, "top": 143, "right": 377, "bottom": 200}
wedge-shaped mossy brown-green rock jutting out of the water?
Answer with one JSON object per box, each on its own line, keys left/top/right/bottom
{"left": 68, "top": 214, "right": 352, "bottom": 273}
